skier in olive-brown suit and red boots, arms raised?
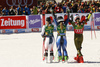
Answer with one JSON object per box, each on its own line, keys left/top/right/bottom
{"left": 69, "top": 13, "right": 92, "bottom": 63}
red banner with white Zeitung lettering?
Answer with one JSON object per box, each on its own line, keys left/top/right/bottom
{"left": 0, "top": 16, "right": 26, "bottom": 29}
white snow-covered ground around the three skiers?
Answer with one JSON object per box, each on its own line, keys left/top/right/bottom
{"left": 0, "top": 31, "right": 100, "bottom": 67}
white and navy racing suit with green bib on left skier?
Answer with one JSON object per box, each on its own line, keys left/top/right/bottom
{"left": 41, "top": 24, "right": 55, "bottom": 56}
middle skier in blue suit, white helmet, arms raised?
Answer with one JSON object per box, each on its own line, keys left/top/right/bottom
{"left": 53, "top": 12, "right": 69, "bottom": 62}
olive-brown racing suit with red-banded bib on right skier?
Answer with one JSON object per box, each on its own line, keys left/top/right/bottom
{"left": 70, "top": 14, "right": 91, "bottom": 56}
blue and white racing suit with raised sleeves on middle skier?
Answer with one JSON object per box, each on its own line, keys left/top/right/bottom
{"left": 54, "top": 18, "right": 69, "bottom": 56}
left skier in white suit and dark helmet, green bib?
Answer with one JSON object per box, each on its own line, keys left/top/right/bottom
{"left": 41, "top": 17, "right": 55, "bottom": 62}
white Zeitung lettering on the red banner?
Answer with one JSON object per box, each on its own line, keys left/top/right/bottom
{"left": 1, "top": 18, "right": 25, "bottom": 27}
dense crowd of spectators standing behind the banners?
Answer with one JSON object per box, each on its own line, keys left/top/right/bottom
{"left": 0, "top": 1, "right": 100, "bottom": 16}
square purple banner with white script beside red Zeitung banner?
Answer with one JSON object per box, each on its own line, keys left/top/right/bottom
{"left": 28, "top": 15, "right": 41, "bottom": 28}
